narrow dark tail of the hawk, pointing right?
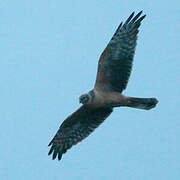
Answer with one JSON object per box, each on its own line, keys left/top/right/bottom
{"left": 127, "top": 97, "right": 158, "bottom": 110}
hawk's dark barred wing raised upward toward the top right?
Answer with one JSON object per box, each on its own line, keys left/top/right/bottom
{"left": 95, "top": 11, "right": 145, "bottom": 92}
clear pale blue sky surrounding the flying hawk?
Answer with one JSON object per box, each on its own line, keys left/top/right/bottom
{"left": 0, "top": 0, "right": 180, "bottom": 180}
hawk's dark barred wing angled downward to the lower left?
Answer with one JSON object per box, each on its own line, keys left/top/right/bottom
{"left": 48, "top": 105, "right": 112, "bottom": 160}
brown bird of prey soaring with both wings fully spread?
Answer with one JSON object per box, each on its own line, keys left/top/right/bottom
{"left": 48, "top": 11, "right": 158, "bottom": 160}
